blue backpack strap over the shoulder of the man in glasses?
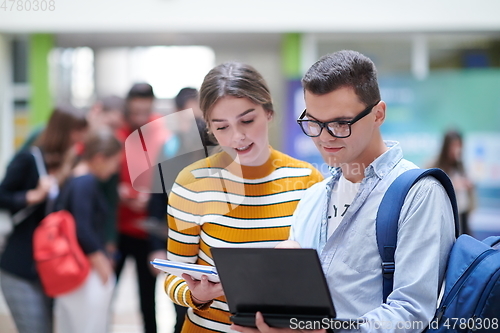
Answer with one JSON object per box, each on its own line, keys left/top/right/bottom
{"left": 375, "top": 168, "right": 459, "bottom": 303}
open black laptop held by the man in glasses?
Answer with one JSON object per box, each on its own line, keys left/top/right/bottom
{"left": 211, "top": 248, "right": 358, "bottom": 328}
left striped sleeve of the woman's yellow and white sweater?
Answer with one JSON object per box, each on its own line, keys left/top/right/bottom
{"left": 165, "top": 169, "right": 211, "bottom": 310}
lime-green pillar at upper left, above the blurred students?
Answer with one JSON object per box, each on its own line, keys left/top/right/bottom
{"left": 28, "top": 34, "right": 54, "bottom": 125}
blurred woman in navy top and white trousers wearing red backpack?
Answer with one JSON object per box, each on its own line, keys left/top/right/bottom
{"left": 54, "top": 128, "right": 122, "bottom": 333}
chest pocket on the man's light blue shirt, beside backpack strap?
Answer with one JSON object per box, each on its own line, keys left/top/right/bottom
{"left": 339, "top": 220, "right": 382, "bottom": 273}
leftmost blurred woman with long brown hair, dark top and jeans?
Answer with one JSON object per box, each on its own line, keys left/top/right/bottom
{"left": 0, "top": 107, "right": 87, "bottom": 333}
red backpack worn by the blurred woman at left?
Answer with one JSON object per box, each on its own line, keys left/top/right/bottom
{"left": 33, "top": 210, "right": 90, "bottom": 297}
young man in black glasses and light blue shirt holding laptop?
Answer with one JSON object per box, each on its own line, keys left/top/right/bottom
{"left": 234, "top": 51, "right": 455, "bottom": 333}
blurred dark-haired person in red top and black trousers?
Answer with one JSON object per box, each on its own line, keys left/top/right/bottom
{"left": 115, "top": 83, "right": 166, "bottom": 333}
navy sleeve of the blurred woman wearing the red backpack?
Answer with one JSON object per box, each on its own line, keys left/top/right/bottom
{"left": 69, "top": 177, "right": 101, "bottom": 254}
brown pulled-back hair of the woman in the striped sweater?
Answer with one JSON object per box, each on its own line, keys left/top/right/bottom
{"left": 200, "top": 62, "right": 274, "bottom": 123}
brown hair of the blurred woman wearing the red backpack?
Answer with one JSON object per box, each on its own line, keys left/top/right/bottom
{"left": 82, "top": 128, "right": 122, "bottom": 161}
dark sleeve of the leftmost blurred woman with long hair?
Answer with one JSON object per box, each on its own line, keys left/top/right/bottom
{"left": 0, "top": 152, "right": 35, "bottom": 214}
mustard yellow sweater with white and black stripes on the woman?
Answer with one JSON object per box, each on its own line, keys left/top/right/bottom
{"left": 165, "top": 149, "right": 323, "bottom": 332}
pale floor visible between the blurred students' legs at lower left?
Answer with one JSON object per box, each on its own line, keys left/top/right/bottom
{"left": 0, "top": 261, "right": 175, "bottom": 333}
